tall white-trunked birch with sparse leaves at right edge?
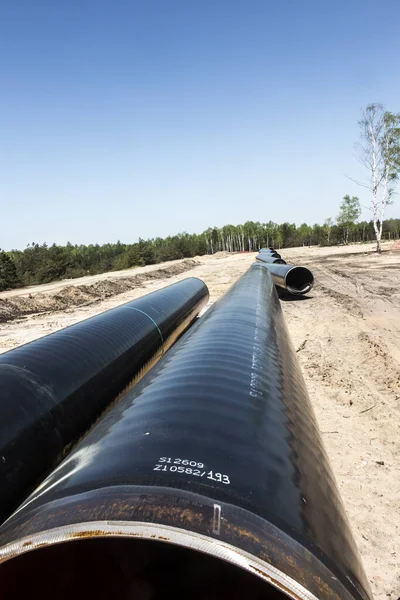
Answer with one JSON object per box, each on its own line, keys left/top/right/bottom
{"left": 353, "top": 104, "right": 400, "bottom": 252}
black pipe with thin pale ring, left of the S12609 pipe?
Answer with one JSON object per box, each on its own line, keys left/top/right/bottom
{"left": 0, "top": 278, "right": 208, "bottom": 521}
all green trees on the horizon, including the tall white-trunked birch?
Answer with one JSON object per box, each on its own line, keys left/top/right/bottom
{"left": 0, "top": 104, "right": 400, "bottom": 290}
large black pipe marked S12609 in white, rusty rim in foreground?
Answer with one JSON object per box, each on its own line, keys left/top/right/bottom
{"left": 0, "top": 263, "right": 371, "bottom": 600}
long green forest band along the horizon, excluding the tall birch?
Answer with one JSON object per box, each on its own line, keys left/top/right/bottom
{"left": 0, "top": 217, "right": 400, "bottom": 290}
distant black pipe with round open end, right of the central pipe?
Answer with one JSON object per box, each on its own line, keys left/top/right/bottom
{"left": 256, "top": 254, "right": 314, "bottom": 296}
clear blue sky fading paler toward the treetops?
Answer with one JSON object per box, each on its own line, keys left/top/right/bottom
{"left": 0, "top": 0, "right": 400, "bottom": 249}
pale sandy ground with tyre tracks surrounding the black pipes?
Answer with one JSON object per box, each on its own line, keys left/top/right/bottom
{"left": 0, "top": 244, "right": 400, "bottom": 600}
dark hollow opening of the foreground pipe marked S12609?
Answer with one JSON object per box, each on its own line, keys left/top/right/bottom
{"left": 0, "top": 537, "right": 287, "bottom": 600}
